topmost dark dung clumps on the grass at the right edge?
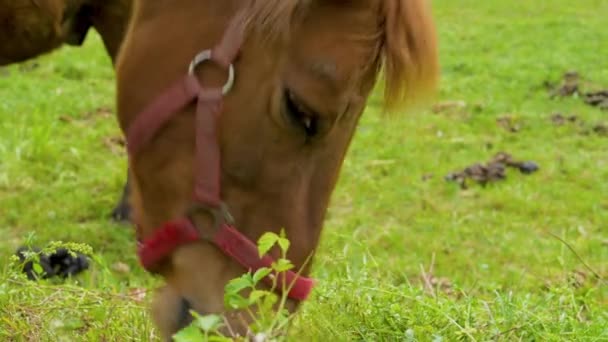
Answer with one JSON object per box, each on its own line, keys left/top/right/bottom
{"left": 545, "top": 71, "right": 608, "bottom": 110}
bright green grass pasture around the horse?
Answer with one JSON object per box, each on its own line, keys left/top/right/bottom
{"left": 0, "top": 0, "right": 608, "bottom": 341}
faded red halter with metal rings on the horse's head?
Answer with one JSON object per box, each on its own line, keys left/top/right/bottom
{"left": 127, "top": 10, "right": 314, "bottom": 300}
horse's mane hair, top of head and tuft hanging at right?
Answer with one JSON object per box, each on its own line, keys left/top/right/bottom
{"left": 247, "top": 0, "right": 439, "bottom": 112}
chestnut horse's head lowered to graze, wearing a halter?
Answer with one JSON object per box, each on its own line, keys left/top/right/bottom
{"left": 117, "top": 0, "right": 438, "bottom": 339}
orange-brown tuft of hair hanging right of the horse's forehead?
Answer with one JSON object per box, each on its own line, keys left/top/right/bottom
{"left": 380, "top": 0, "right": 439, "bottom": 111}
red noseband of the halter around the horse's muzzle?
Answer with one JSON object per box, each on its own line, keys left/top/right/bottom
{"left": 138, "top": 219, "right": 315, "bottom": 301}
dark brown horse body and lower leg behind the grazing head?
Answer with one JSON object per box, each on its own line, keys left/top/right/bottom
{"left": 0, "top": 0, "right": 132, "bottom": 220}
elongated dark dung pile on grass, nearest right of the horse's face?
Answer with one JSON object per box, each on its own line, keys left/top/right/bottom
{"left": 445, "top": 152, "right": 539, "bottom": 189}
